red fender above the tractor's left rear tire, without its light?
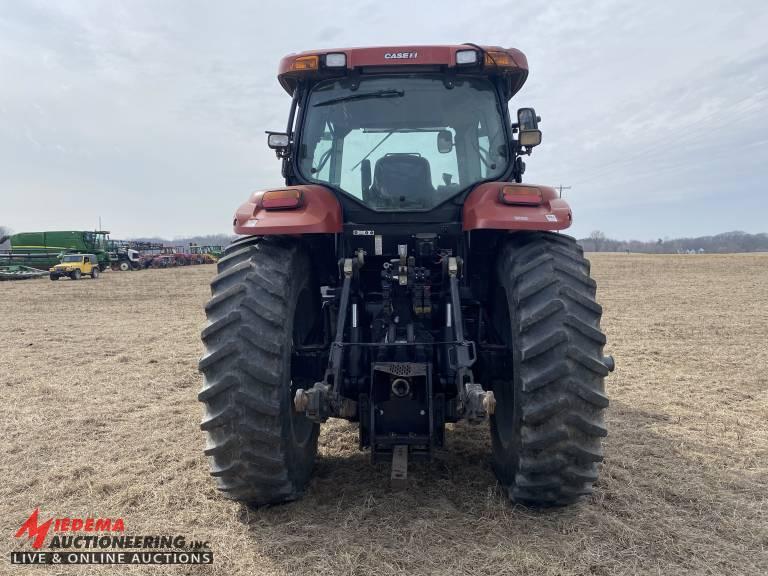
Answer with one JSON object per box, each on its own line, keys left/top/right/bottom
{"left": 233, "top": 184, "right": 342, "bottom": 236}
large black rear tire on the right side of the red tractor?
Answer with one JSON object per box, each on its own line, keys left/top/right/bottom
{"left": 491, "top": 233, "right": 609, "bottom": 505}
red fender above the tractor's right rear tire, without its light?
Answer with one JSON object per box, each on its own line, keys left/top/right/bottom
{"left": 462, "top": 182, "right": 573, "bottom": 232}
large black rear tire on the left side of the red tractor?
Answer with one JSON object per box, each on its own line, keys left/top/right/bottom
{"left": 198, "top": 237, "right": 320, "bottom": 505}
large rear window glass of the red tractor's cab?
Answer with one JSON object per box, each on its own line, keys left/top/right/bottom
{"left": 298, "top": 76, "right": 509, "bottom": 210}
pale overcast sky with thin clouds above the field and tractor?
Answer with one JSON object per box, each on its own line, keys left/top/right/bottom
{"left": 0, "top": 0, "right": 768, "bottom": 240}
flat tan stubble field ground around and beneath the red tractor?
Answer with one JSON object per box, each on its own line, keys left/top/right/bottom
{"left": 0, "top": 254, "right": 768, "bottom": 575}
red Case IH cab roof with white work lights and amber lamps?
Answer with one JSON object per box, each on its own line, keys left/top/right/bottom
{"left": 277, "top": 44, "right": 528, "bottom": 98}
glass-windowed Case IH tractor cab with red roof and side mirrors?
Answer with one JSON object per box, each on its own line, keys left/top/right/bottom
{"left": 269, "top": 46, "right": 540, "bottom": 221}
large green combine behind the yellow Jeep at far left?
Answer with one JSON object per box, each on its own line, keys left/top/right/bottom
{"left": 0, "top": 230, "right": 110, "bottom": 270}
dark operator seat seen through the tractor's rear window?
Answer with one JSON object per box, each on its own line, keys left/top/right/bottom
{"left": 371, "top": 153, "right": 435, "bottom": 209}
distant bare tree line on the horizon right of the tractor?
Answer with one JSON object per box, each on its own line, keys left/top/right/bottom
{"left": 579, "top": 230, "right": 768, "bottom": 254}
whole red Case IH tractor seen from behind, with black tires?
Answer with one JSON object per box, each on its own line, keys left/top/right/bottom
{"left": 199, "top": 44, "right": 613, "bottom": 505}
